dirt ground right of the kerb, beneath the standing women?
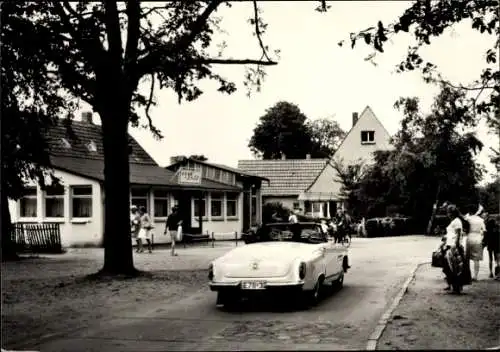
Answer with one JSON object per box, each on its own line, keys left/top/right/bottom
{"left": 378, "top": 262, "right": 500, "bottom": 350}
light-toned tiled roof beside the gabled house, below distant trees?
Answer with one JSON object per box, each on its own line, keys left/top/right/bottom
{"left": 238, "top": 159, "right": 328, "bottom": 196}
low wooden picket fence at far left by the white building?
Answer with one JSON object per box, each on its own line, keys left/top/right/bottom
{"left": 11, "top": 223, "right": 63, "bottom": 253}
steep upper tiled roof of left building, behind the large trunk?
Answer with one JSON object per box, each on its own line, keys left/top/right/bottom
{"left": 47, "top": 120, "right": 156, "bottom": 165}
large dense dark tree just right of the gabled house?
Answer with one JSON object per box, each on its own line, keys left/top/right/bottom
{"left": 356, "top": 85, "right": 482, "bottom": 228}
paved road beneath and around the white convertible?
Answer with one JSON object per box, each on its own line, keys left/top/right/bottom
{"left": 32, "top": 236, "right": 438, "bottom": 352}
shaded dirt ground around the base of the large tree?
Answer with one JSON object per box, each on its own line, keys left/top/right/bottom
{"left": 2, "top": 248, "right": 227, "bottom": 348}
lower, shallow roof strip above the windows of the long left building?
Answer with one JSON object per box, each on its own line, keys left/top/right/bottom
{"left": 51, "top": 156, "right": 240, "bottom": 191}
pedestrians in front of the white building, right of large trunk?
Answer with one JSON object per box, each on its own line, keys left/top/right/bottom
{"left": 130, "top": 205, "right": 182, "bottom": 256}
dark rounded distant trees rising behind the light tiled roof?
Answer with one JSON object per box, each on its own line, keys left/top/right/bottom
{"left": 248, "top": 101, "right": 345, "bottom": 159}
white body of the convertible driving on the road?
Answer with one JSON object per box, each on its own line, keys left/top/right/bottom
{"left": 209, "top": 232, "right": 348, "bottom": 304}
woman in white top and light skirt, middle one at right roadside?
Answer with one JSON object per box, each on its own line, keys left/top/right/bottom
{"left": 465, "top": 206, "right": 486, "bottom": 281}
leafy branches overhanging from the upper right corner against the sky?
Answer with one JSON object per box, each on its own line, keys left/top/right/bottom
{"left": 348, "top": 0, "right": 500, "bottom": 133}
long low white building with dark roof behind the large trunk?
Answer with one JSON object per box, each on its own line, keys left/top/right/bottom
{"left": 9, "top": 113, "right": 264, "bottom": 246}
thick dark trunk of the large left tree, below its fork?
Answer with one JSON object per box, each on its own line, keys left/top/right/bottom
{"left": 99, "top": 103, "right": 138, "bottom": 275}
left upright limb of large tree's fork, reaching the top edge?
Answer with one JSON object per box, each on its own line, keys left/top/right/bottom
{"left": 104, "top": 0, "right": 123, "bottom": 70}
